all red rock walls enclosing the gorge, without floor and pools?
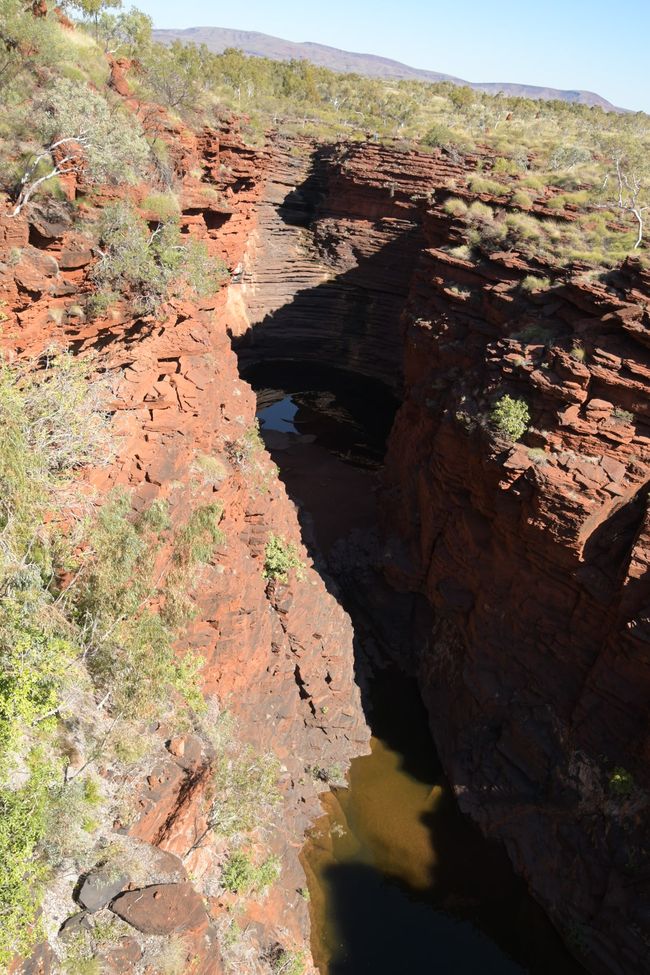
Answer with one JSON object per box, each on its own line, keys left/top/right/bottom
{"left": 5, "top": 103, "right": 650, "bottom": 975}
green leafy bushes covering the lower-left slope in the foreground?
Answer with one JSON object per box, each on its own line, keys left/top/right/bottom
{"left": 0, "top": 354, "right": 205, "bottom": 963}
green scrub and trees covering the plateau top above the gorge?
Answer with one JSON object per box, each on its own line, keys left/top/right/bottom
{"left": 0, "top": 0, "right": 650, "bottom": 270}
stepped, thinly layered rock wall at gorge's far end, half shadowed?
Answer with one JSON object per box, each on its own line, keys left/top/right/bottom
{"left": 237, "top": 140, "right": 454, "bottom": 389}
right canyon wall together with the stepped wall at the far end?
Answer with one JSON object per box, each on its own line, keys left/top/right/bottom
{"left": 239, "top": 137, "right": 650, "bottom": 975}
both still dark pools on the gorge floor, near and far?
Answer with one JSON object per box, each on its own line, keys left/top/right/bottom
{"left": 246, "top": 363, "right": 583, "bottom": 975}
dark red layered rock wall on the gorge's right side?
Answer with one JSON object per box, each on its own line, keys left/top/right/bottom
{"left": 384, "top": 234, "right": 650, "bottom": 973}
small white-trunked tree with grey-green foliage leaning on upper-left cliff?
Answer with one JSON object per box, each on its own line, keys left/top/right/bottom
{"left": 12, "top": 79, "right": 149, "bottom": 217}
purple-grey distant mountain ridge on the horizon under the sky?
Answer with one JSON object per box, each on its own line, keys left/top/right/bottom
{"left": 154, "top": 27, "right": 623, "bottom": 112}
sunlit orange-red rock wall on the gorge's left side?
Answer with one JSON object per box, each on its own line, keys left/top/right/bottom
{"left": 0, "top": 121, "right": 368, "bottom": 975}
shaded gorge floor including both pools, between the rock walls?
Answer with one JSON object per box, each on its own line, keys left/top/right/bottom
{"left": 246, "top": 362, "right": 580, "bottom": 975}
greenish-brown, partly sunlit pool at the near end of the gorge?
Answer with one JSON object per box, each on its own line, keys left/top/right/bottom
{"left": 303, "top": 675, "right": 582, "bottom": 975}
